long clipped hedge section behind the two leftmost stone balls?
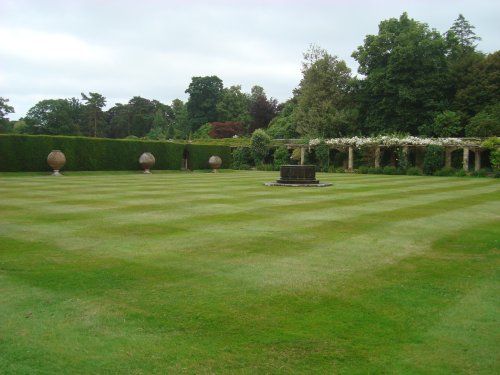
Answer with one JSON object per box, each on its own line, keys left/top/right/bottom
{"left": 0, "top": 134, "right": 191, "bottom": 172}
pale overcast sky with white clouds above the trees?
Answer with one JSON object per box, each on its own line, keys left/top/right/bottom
{"left": 0, "top": 0, "right": 500, "bottom": 120}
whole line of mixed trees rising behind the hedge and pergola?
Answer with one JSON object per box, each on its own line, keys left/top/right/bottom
{"left": 0, "top": 13, "right": 500, "bottom": 139}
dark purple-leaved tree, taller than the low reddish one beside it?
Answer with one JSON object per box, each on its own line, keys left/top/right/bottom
{"left": 248, "top": 86, "right": 279, "bottom": 133}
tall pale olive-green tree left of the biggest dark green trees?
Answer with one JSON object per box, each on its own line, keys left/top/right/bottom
{"left": 295, "top": 45, "right": 356, "bottom": 137}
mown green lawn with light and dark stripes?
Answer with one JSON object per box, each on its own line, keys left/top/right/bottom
{"left": 0, "top": 171, "right": 500, "bottom": 375}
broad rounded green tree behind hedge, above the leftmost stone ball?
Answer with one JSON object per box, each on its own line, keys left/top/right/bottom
{"left": 23, "top": 99, "right": 79, "bottom": 135}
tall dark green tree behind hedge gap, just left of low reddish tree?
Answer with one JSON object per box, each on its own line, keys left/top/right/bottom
{"left": 186, "top": 76, "right": 223, "bottom": 132}
